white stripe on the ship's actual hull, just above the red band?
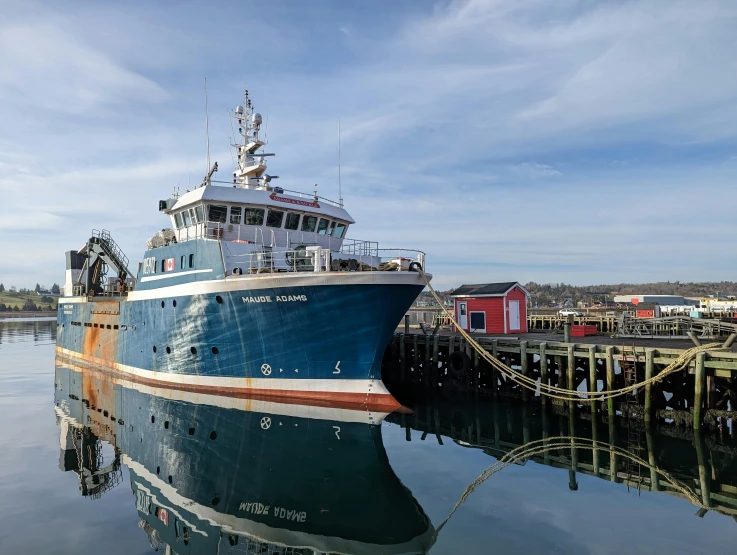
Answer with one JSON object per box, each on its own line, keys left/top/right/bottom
{"left": 56, "top": 347, "right": 391, "bottom": 396}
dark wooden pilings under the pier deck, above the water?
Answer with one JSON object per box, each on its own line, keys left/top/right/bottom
{"left": 382, "top": 333, "right": 737, "bottom": 428}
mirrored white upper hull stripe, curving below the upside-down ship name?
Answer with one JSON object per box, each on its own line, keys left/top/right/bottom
{"left": 123, "top": 454, "right": 434, "bottom": 555}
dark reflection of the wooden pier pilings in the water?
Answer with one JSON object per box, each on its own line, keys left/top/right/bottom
{"left": 387, "top": 402, "right": 737, "bottom": 521}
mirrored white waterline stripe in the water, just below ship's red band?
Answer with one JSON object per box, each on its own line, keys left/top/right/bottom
{"left": 57, "top": 364, "right": 389, "bottom": 424}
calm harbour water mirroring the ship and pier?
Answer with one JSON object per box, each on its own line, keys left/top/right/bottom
{"left": 0, "top": 322, "right": 737, "bottom": 555}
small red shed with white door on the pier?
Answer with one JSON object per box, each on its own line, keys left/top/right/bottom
{"left": 450, "top": 281, "right": 530, "bottom": 334}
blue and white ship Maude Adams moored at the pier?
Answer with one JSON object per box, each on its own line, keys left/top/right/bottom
{"left": 57, "top": 91, "right": 425, "bottom": 406}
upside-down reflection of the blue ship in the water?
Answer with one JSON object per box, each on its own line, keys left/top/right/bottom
{"left": 55, "top": 366, "right": 434, "bottom": 554}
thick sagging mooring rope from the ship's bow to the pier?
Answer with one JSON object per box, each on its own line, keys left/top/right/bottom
{"left": 417, "top": 267, "right": 728, "bottom": 403}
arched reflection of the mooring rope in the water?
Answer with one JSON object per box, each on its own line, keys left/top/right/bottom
{"left": 430, "top": 436, "right": 720, "bottom": 547}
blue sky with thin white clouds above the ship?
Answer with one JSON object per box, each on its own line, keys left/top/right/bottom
{"left": 0, "top": 0, "right": 737, "bottom": 287}
